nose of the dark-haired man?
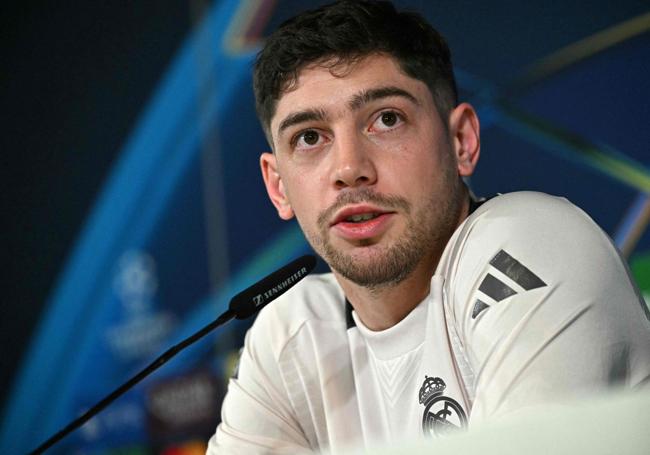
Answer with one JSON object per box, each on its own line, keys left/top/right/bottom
{"left": 332, "top": 134, "right": 377, "bottom": 189}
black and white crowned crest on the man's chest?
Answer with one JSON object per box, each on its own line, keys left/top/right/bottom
{"left": 420, "top": 376, "right": 467, "bottom": 436}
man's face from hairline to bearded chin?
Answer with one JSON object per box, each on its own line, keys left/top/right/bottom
{"left": 261, "top": 55, "right": 473, "bottom": 288}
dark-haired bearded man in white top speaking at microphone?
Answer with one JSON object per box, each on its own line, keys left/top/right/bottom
{"left": 208, "top": 2, "right": 650, "bottom": 453}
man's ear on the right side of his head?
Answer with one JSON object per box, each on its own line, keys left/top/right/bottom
{"left": 449, "top": 103, "right": 481, "bottom": 177}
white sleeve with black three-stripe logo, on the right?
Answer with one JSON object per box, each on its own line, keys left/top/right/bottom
{"left": 447, "top": 193, "right": 650, "bottom": 424}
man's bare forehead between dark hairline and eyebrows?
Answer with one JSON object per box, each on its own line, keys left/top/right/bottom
{"left": 270, "top": 55, "right": 432, "bottom": 136}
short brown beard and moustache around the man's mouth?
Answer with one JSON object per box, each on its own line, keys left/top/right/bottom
{"left": 307, "top": 177, "right": 462, "bottom": 291}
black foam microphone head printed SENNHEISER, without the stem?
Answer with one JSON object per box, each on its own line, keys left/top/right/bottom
{"left": 229, "top": 254, "right": 316, "bottom": 319}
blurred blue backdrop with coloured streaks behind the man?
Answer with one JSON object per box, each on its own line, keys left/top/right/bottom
{"left": 0, "top": 0, "right": 650, "bottom": 454}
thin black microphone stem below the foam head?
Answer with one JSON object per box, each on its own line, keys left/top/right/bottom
{"left": 30, "top": 309, "right": 235, "bottom": 455}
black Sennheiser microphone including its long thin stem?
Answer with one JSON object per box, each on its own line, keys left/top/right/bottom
{"left": 30, "top": 254, "right": 316, "bottom": 454}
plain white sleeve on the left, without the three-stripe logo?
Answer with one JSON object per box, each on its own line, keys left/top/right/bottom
{"left": 207, "top": 311, "right": 309, "bottom": 455}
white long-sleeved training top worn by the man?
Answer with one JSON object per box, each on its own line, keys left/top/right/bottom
{"left": 208, "top": 192, "right": 650, "bottom": 454}
